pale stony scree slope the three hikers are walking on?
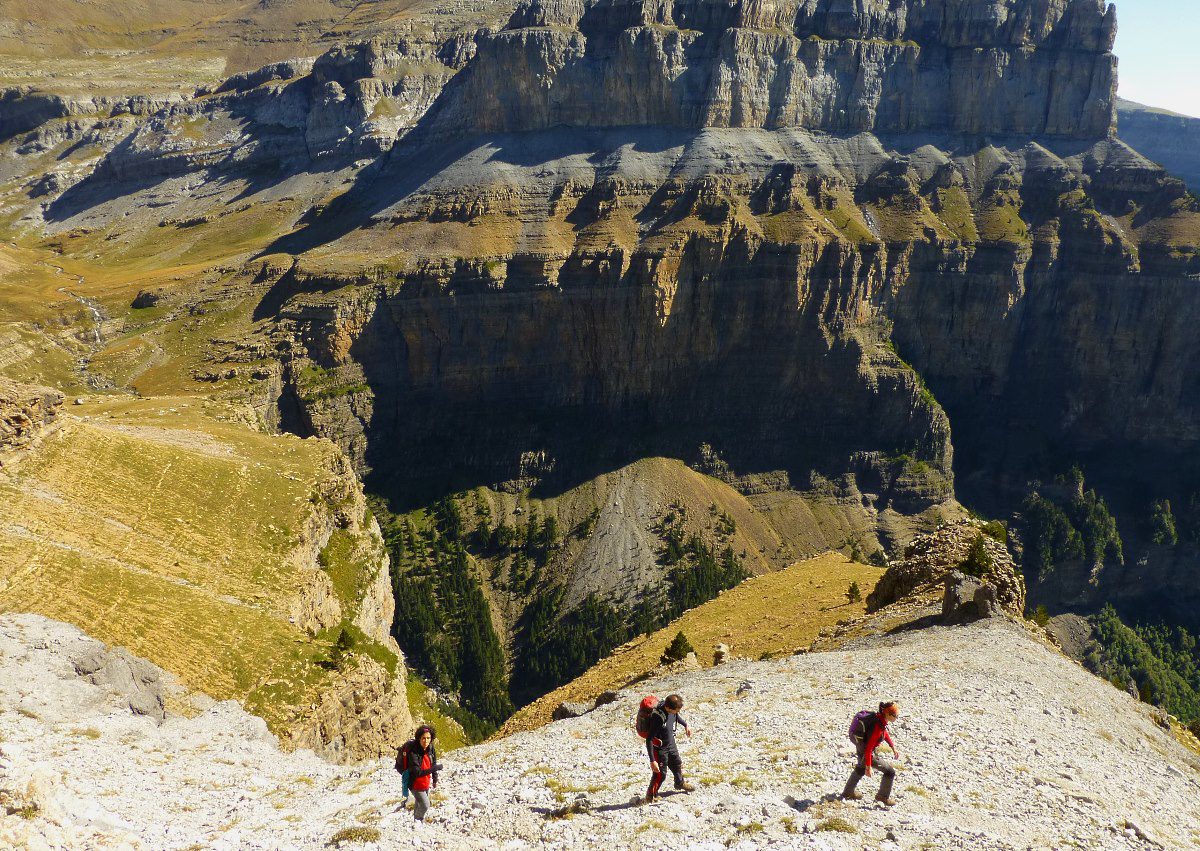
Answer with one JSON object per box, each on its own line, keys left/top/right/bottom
{"left": 0, "top": 607, "right": 1200, "bottom": 850}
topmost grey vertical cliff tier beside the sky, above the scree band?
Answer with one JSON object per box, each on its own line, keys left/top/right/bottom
{"left": 422, "top": 0, "right": 1116, "bottom": 139}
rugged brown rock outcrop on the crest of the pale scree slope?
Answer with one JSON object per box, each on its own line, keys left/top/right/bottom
{"left": 866, "top": 520, "right": 1025, "bottom": 621}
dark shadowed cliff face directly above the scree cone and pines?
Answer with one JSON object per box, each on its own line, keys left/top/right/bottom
{"left": 349, "top": 237, "right": 947, "bottom": 510}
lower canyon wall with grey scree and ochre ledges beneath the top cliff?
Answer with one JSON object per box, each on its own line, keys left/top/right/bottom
{"left": 262, "top": 117, "right": 1200, "bottom": 511}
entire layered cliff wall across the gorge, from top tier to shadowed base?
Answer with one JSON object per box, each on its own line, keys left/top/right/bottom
{"left": 6, "top": 0, "right": 1200, "bottom": 657}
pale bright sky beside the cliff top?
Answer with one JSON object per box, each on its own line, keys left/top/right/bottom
{"left": 1115, "top": 0, "right": 1200, "bottom": 118}
